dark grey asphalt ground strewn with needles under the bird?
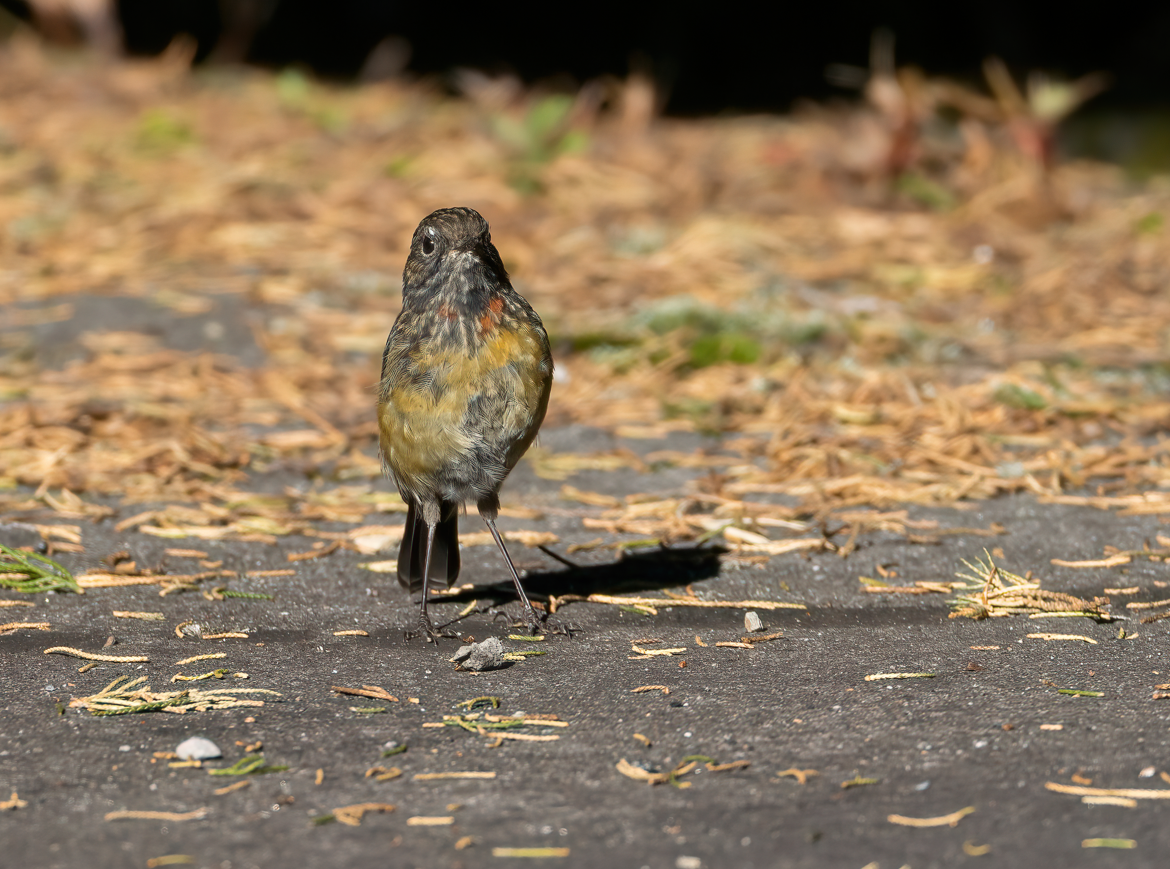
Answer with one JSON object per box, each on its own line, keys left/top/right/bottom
{"left": 0, "top": 295, "right": 1170, "bottom": 869}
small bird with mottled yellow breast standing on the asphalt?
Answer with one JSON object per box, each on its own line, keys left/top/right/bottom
{"left": 378, "top": 208, "right": 552, "bottom": 640}
